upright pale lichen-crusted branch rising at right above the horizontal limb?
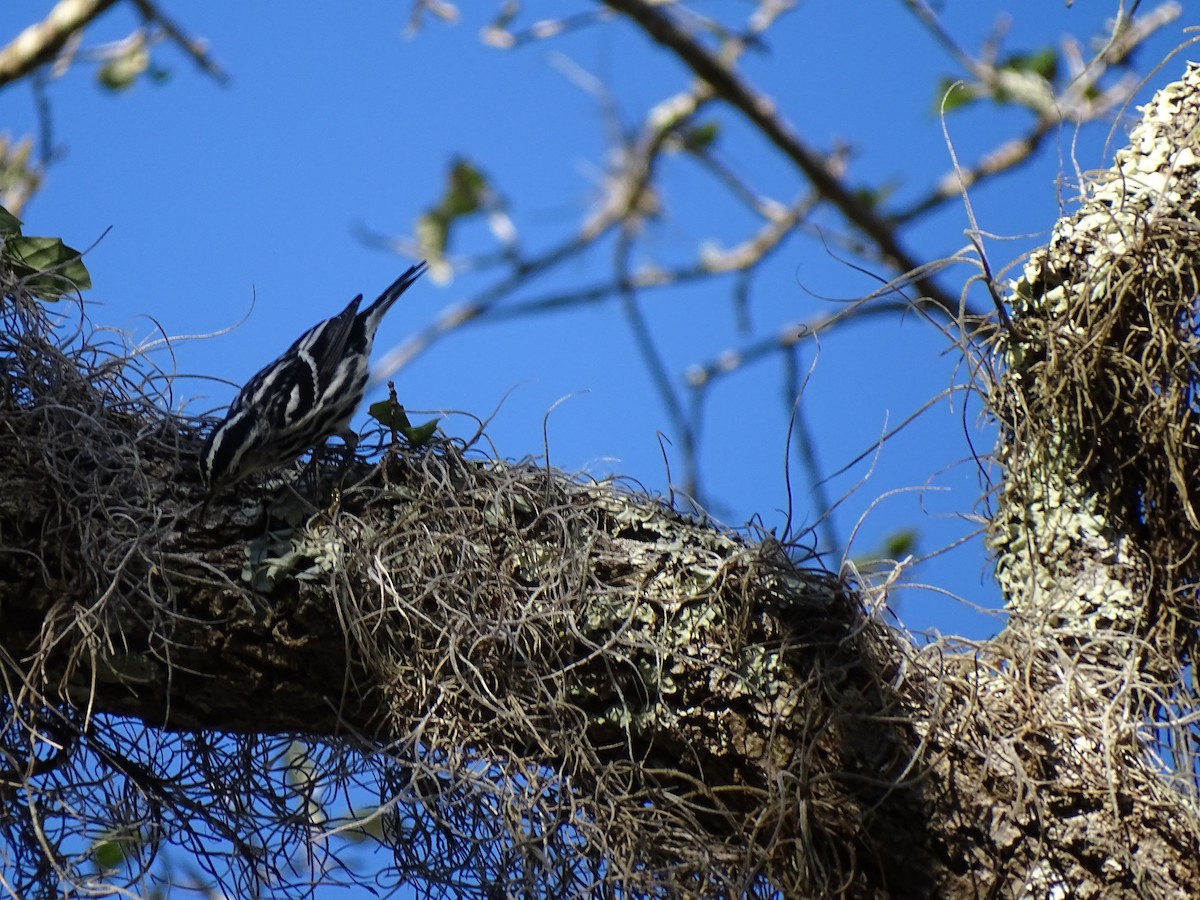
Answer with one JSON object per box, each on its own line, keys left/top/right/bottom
{"left": 991, "top": 66, "right": 1200, "bottom": 655}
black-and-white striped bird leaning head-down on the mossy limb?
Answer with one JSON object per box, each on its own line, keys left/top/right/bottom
{"left": 200, "top": 263, "right": 426, "bottom": 493}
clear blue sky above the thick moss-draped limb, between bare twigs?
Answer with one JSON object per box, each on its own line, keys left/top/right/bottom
{"left": 0, "top": 0, "right": 1182, "bottom": 636}
